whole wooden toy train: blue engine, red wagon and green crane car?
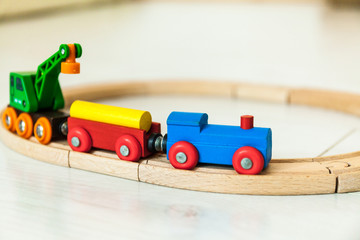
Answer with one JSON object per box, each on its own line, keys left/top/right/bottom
{"left": 2, "top": 44, "right": 272, "bottom": 174}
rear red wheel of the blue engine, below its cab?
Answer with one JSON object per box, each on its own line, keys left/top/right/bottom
{"left": 169, "top": 141, "right": 199, "bottom": 170}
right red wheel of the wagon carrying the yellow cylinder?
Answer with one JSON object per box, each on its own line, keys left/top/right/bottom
{"left": 115, "top": 135, "right": 141, "bottom": 162}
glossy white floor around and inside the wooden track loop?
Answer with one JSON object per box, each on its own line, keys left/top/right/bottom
{"left": 0, "top": 0, "right": 360, "bottom": 239}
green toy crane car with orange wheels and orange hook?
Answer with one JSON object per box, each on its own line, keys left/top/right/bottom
{"left": 2, "top": 43, "right": 82, "bottom": 144}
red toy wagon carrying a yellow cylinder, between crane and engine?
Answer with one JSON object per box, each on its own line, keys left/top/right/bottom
{"left": 68, "top": 101, "right": 162, "bottom": 161}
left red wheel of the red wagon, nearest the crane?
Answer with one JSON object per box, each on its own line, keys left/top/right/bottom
{"left": 67, "top": 127, "right": 92, "bottom": 152}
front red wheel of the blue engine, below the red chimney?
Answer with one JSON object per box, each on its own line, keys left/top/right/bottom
{"left": 232, "top": 146, "right": 264, "bottom": 175}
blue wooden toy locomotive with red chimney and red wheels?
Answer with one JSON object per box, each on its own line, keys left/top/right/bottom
{"left": 166, "top": 112, "right": 272, "bottom": 174}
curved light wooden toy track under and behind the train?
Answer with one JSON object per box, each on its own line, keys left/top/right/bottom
{"left": 0, "top": 81, "right": 360, "bottom": 195}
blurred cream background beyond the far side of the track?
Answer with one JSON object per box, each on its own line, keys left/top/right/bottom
{"left": 0, "top": 0, "right": 360, "bottom": 96}
